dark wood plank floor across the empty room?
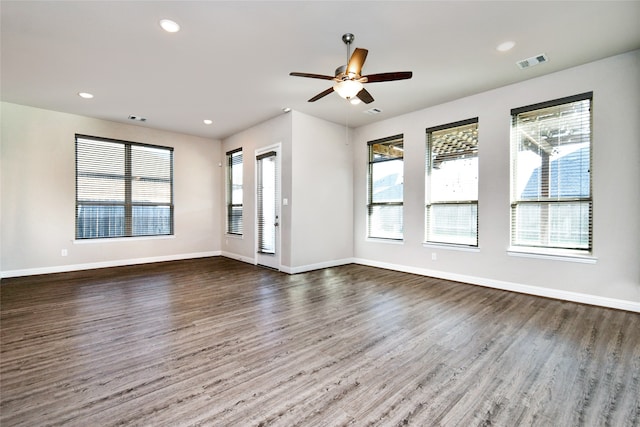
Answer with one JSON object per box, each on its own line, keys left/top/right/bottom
{"left": 0, "top": 257, "right": 640, "bottom": 427}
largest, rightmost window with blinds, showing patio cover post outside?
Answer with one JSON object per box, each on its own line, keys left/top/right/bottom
{"left": 511, "top": 92, "right": 593, "bottom": 252}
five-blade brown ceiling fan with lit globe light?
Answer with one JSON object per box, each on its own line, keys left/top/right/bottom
{"left": 289, "top": 33, "right": 413, "bottom": 104}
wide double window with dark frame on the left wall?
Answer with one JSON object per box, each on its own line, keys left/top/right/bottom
{"left": 76, "top": 135, "right": 173, "bottom": 239}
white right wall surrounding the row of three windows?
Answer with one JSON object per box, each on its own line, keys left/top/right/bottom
{"left": 354, "top": 51, "right": 640, "bottom": 310}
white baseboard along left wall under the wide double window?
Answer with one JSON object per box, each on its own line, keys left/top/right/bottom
{"left": 0, "top": 251, "right": 221, "bottom": 279}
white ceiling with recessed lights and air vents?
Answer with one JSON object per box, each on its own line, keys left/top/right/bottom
{"left": 0, "top": 0, "right": 640, "bottom": 139}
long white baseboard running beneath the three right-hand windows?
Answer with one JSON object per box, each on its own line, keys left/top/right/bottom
{"left": 353, "top": 258, "right": 640, "bottom": 313}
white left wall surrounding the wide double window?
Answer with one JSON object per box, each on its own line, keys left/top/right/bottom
{"left": 0, "top": 103, "right": 223, "bottom": 277}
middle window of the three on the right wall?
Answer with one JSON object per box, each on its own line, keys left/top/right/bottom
{"left": 425, "top": 118, "right": 478, "bottom": 246}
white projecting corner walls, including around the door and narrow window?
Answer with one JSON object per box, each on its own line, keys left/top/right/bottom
{"left": 220, "top": 111, "right": 353, "bottom": 273}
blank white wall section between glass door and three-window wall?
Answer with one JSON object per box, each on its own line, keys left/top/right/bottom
{"left": 289, "top": 111, "right": 353, "bottom": 272}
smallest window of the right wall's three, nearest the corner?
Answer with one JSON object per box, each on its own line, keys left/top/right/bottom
{"left": 368, "top": 135, "right": 404, "bottom": 240}
